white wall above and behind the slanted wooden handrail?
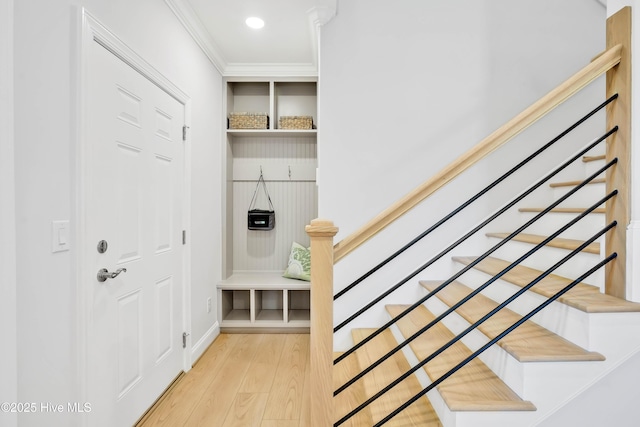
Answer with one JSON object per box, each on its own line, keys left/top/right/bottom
{"left": 318, "top": 0, "right": 605, "bottom": 346}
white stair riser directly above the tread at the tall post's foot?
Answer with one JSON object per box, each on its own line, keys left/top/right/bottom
{"left": 492, "top": 239, "right": 604, "bottom": 290}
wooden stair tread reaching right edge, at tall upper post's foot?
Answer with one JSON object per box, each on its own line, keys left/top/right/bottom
{"left": 453, "top": 257, "right": 640, "bottom": 313}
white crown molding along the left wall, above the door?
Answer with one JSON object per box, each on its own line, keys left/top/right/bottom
{"left": 164, "top": 0, "right": 227, "bottom": 76}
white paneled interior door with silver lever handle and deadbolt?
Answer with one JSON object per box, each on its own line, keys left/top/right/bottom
{"left": 84, "top": 43, "right": 185, "bottom": 426}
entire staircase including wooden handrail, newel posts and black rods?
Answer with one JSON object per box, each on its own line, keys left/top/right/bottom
{"left": 306, "top": 7, "right": 640, "bottom": 427}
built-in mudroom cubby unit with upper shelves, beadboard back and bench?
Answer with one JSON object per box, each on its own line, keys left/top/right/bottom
{"left": 218, "top": 77, "right": 318, "bottom": 330}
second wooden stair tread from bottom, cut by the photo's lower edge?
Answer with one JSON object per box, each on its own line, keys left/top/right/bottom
{"left": 350, "top": 329, "right": 442, "bottom": 427}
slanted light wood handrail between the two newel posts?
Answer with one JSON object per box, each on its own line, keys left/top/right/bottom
{"left": 333, "top": 45, "right": 622, "bottom": 262}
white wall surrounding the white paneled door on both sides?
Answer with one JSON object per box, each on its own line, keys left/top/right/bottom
{"left": 15, "top": 0, "right": 222, "bottom": 426}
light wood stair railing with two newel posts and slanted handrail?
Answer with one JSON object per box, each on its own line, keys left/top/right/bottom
{"left": 306, "top": 7, "right": 631, "bottom": 427}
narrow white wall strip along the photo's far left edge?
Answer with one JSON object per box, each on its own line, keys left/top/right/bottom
{"left": 0, "top": 0, "right": 18, "bottom": 427}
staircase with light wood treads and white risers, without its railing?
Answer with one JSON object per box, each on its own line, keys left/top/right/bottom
{"left": 334, "top": 156, "right": 640, "bottom": 427}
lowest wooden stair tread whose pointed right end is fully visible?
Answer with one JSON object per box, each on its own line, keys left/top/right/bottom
{"left": 387, "top": 305, "right": 536, "bottom": 411}
